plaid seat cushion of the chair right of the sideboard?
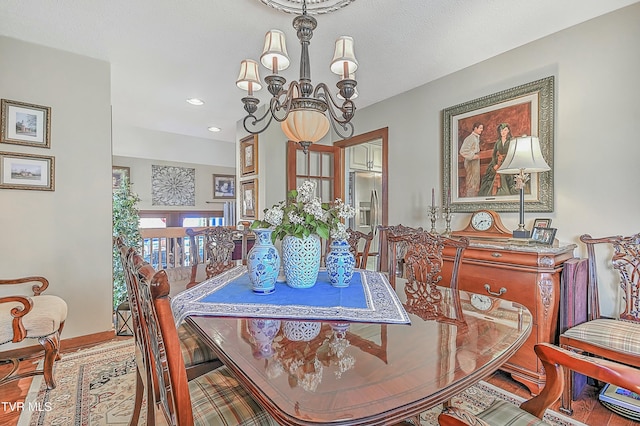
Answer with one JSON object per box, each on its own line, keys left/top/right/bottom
{"left": 562, "top": 319, "right": 640, "bottom": 355}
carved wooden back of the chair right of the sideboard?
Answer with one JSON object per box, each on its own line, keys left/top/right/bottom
{"left": 580, "top": 233, "right": 640, "bottom": 321}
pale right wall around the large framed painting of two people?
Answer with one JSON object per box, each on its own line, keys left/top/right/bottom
{"left": 355, "top": 3, "right": 640, "bottom": 315}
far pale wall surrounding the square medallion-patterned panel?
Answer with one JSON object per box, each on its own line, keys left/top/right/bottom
{"left": 113, "top": 154, "right": 238, "bottom": 211}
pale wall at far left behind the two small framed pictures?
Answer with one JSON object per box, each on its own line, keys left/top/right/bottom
{"left": 0, "top": 36, "right": 112, "bottom": 344}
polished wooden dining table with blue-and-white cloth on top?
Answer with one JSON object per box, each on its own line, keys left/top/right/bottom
{"left": 172, "top": 266, "right": 532, "bottom": 425}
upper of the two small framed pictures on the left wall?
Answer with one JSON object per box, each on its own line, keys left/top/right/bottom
{"left": 0, "top": 99, "right": 51, "bottom": 148}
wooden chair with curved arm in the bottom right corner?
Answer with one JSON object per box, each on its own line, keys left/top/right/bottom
{"left": 438, "top": 343, "right": 640, "bottom": 426}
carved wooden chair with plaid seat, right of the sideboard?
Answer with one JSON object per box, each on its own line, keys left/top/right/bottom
{"left": 560, "top": 233, "right": 640, "bottom": 414}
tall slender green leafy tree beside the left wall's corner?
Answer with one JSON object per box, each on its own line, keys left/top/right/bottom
{"left": 113, "top": 176, "right": 142, "bottom": 311}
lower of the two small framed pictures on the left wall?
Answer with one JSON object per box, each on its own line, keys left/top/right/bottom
{"left": 0, "top": 152, "right": 55, "bottom": 191}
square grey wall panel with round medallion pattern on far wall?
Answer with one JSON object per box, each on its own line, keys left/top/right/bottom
{"left": 151, "top": 165, "right": 196, "bottom": 206}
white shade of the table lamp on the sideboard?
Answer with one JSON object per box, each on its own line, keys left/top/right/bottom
{"left": 496, "top": 135, "right": 551, "bottom": 175}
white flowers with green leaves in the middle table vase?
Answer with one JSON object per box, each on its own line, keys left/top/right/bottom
{"left": 251, "top": 180, "right": 355, "bottom": 241}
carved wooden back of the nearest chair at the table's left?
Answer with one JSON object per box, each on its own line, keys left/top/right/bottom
{"left": 121, "top": 241, "right": 193, "bottom": 425}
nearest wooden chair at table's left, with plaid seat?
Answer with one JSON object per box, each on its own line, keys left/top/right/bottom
{"left": 125, "top": 246, "right": 277, "bottom": 426}
